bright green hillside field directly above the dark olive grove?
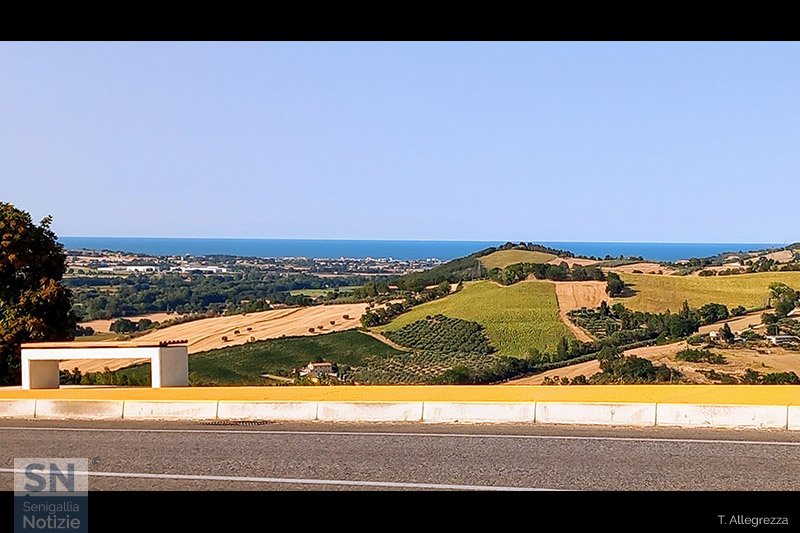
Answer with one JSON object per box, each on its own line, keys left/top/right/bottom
{"left": 378, "top": 281, "right": 573, "bottom": 356}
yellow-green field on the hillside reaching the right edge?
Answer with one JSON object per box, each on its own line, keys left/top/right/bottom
{"left": 614, "top": 272, "right": 800, "bottom": 312}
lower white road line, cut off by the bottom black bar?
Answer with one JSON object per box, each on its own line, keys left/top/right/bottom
{"left": 0, "top": 468, "right": 560, "bottom": 492}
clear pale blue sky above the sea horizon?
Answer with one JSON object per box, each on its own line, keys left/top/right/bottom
{"left": 0, "top": 43, "right": 800, "bottom": 242}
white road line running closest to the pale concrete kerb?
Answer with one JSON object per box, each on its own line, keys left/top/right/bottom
{"left": 0, "top": 426, "right": 800, "bottom": 446}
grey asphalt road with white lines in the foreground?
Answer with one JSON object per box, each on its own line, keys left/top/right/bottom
{"left": 0, "top": 420, "right": 800, "bottom": 490}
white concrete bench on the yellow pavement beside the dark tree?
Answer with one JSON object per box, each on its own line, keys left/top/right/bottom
{"left": 22, "top": 341, "right": 189, "bottom": 389}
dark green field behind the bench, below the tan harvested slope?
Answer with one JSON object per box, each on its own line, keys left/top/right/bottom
{"left": 118, "top": 330, "right": 403, "bottom": 385}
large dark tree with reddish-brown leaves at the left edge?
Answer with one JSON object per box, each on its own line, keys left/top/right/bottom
{"left": 0, "top": 202, "right": 77, "bottom": 385}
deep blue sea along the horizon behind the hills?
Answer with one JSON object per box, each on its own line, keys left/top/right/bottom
{"left": 59, "top": 236, "right": 783, "bottom": 261}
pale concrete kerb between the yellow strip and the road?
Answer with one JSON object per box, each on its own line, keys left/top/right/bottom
{"left": 0, "top": 399, "right": 800, "bottom": 430}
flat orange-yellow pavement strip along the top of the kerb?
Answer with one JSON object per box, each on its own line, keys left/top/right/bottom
{"left": 0, "top": 385, "right": 800, "bottom": 405}
